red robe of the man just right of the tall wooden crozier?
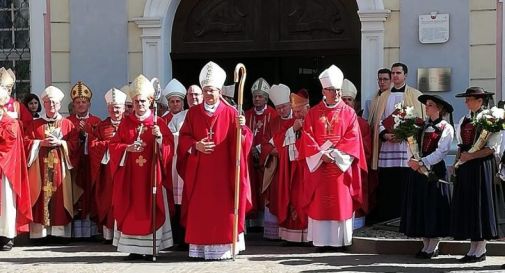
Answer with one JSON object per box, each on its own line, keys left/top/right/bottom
{"left": 245, "top": 105, "right": 278, "bottom": 212}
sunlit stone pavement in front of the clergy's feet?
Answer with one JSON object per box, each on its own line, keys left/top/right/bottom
{"left": 0, "top": 233, "right": 505, "bottom": 273}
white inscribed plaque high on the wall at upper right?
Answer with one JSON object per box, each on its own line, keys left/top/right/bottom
{"left": 419, "top": 12, "right": 449, "bottom": 44}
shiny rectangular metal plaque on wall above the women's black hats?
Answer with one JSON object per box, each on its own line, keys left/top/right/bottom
{"left": 417, "top": 67, "right": 451, "bottom": 92}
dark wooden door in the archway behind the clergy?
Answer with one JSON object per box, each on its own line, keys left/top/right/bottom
{"left": 170, "top": 0, "right": 361, "bottom": 108}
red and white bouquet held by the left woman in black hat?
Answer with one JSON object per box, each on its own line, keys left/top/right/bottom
{"left": 392, "top": 103, "right": 429, "bottom": 176}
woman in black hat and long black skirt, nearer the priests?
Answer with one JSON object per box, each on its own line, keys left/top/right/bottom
{"left": 400, "top": 95, "right": 454, "bottom": 259}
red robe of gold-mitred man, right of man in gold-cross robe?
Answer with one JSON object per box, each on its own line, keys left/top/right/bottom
{"left": 68, "top": 114, "right": 100, "bottom": 219}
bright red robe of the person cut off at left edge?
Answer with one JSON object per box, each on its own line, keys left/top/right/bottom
{"left": 0, "top": 113, "right": 32, "bottom": 232}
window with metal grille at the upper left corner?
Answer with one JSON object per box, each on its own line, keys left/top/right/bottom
{"left": 0, "top": 0, "right": 30, "bottom": 98}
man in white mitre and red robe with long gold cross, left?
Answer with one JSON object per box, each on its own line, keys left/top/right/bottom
{"left": 25, "top": 86, "right": 82, "bottom": 238}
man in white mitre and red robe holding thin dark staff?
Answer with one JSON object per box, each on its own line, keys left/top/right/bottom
{"left": 109, "top": 75, "right": 174, "bottom": 260}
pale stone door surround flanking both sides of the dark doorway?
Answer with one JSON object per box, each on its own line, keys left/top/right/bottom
{"left": 135, "top": 0, "right": 390, "bottom": 104}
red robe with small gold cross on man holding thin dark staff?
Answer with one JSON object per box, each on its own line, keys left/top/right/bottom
{"left": 109, "top": 113, "right": 174, "bottom": 235}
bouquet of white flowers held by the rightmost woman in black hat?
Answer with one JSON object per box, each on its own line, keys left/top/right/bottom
{"left": 454, "top": 107, "right": 505, "bottom": 168}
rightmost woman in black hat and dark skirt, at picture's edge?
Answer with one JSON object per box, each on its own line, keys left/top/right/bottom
{"left": 451, "top": 87, "right": 505, "bottom": 262}
